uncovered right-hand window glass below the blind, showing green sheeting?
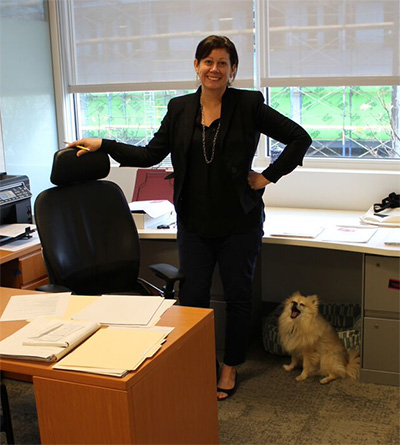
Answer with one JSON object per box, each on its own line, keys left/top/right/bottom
{"left": 269, "top": 86, "right": 400, "bottom": 159}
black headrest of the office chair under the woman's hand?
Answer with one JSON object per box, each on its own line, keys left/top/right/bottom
{"left": 50, "top": 148, "right": 110, "bottom": 185}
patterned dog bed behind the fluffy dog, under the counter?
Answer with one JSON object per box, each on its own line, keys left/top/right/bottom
{"left": 262, "top": 303, "right": 361, "bottom": 355}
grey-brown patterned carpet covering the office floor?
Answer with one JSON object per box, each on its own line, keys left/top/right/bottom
{"left": 1, "top": 339, "right": 400, "bottom": 445}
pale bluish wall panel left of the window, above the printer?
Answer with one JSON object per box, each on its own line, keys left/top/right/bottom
{"left": 0, "top": 16, "right": 59, "bottom": 203}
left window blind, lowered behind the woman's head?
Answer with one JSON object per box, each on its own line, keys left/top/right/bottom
{"left": 59, "top": 0, "right": 254, "bottom": 93}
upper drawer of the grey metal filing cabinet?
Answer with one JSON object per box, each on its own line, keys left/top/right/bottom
{"left": 364, "top": 255, "right": 400, "bottom": 314}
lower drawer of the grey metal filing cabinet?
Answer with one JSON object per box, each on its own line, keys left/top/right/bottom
{"left": 362, "top": 317, "right": 400, "bottom": 373}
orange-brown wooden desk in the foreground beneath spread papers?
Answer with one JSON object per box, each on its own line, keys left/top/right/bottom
{"left": 0, "top": 288, "right": 219, "bottom": 444}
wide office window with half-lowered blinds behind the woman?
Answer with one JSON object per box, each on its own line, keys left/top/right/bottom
{"left": 54, "top": 0, "right": 400, "bottom": 165}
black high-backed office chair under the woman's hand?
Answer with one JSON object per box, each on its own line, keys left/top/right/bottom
{"left": 34, "top": 148, "right": 183, "bottom": 298}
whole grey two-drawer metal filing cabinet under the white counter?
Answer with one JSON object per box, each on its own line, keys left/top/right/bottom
{"left": 361, "top": 255, "right": 400, "bottom": 386}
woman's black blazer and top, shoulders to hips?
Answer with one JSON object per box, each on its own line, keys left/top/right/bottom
{"left": 102, "top": 88, "right": 312, "bottom": 236}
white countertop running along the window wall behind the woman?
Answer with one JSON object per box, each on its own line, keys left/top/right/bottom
{"left": 139, "top": 207, "right": 400, "bottom": 257}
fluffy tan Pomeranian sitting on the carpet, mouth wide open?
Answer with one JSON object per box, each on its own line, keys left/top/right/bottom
{"left": 279, "top": 292, "right": 360, "bottom": 384}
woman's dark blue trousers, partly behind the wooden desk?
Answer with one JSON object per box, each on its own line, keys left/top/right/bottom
{"left": 178, "top": 225, "right": 263, "bottom": 366}
